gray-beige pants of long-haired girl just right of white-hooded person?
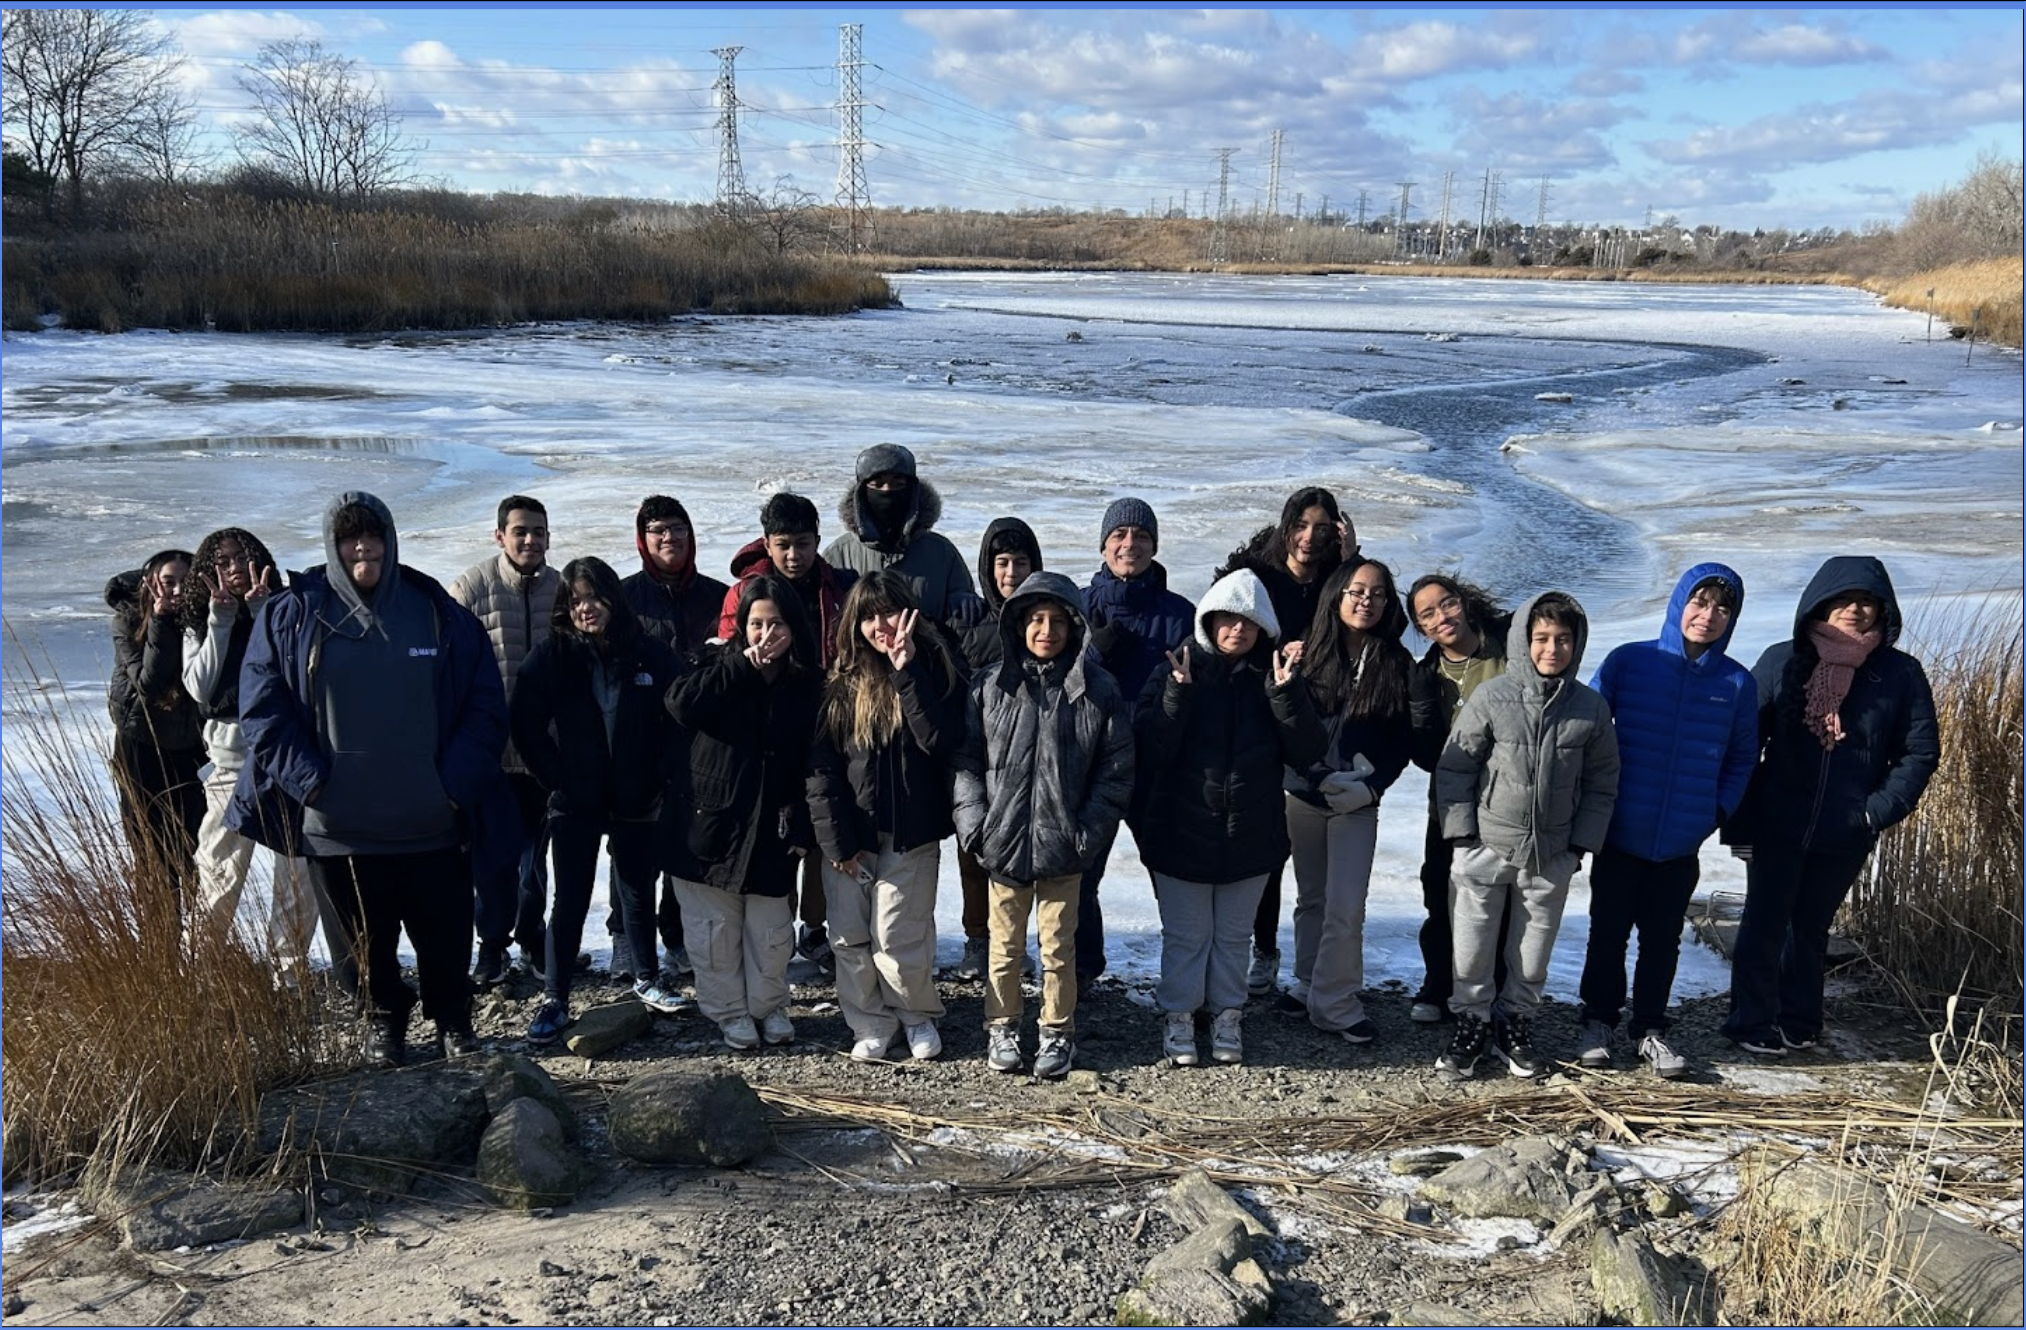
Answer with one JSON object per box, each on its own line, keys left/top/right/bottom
{"left": 1287, "top": 795, "right": 1380, "bottom": 1032}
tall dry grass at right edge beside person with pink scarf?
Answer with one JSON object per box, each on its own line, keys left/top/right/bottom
{"left": 1846, "top": 596, "right": 2026, "bottom": 1021}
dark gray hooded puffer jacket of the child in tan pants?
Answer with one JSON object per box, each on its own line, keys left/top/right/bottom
{"left": 956, "top": 572, "right": 1133, "bottom": 884}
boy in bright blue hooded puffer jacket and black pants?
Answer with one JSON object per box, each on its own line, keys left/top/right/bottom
{"left": 1576, "top": 564, "right": 1759, "bottom": 1079}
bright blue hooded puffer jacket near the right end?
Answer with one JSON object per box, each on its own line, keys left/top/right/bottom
{"left": 1590, "top": 564, "right": 1759, "bottom": 864}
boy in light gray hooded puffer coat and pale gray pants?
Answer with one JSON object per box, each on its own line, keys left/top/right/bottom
{"left": 1434, "top": 592, "right": 1619, "bottom": 1079}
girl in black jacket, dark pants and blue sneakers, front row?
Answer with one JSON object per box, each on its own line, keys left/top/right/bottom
{"left": 511, "top": 558, "right": 685, "bottom": 1044}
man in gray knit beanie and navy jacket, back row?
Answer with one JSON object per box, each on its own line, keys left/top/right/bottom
{"left": 1076, "top": 497, "right": 1195, "bottom": 987}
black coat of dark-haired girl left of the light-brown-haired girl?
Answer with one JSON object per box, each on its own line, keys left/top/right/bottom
{"left": 660, "top": 643, "right": 823, "bottom": 896}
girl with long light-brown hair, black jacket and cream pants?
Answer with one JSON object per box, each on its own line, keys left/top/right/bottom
{"left": 808, "top": 572, "right": 964, "bottom": 1062}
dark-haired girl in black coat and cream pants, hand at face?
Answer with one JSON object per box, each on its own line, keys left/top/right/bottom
{"left": 663, "top": 574, "right": 823, "bottom": 1048}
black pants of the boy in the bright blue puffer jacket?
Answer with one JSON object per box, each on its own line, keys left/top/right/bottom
{"left": 1582, "top": 845, "right": 1702, "bottom": 1040}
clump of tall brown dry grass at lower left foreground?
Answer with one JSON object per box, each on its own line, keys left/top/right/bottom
{"left": 0, "top": 648, "right": 338, "bottom": 1178}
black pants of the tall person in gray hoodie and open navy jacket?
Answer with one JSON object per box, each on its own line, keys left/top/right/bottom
{"left": 308, "top": 845, "right": 472, "bottom": 1034}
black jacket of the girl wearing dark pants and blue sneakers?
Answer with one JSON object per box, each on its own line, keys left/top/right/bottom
{"left": 509, "top": 633, "right": 683, "bottom": 821}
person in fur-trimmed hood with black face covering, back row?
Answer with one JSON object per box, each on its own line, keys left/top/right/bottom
{"left": 823, "top": 444, "right": 985, "bottom": 632}
